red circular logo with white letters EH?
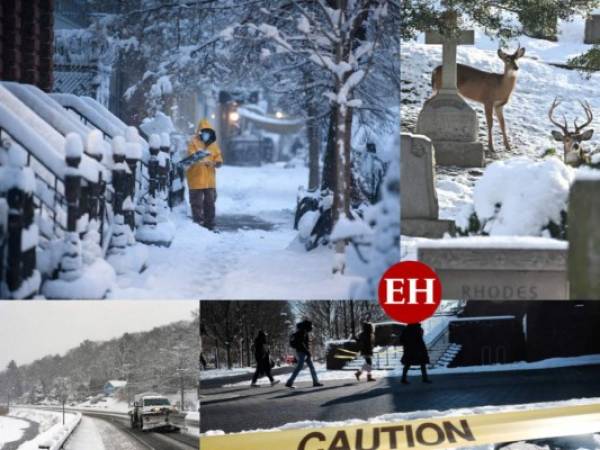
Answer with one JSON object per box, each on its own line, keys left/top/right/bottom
{"left": 379, "top": 261, "right": 442, "bottom": 324}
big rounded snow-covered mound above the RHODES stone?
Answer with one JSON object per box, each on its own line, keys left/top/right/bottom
{"left": 457, "top": 157, "right": 575, "bottom": 236}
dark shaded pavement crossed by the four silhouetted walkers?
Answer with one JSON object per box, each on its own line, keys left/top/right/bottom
{"left": 201, "top": 365, "right": 600, "bottom": 432}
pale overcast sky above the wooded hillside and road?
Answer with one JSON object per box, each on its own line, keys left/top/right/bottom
{"left": 0, "top": 300, "right": 198, "bottom": 371}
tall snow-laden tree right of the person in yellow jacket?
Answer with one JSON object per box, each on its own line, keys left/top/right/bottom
{"left": 216, "top": 0, "right": 396, "bottom": 271}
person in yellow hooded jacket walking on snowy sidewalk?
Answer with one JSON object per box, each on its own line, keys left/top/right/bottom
{"left": 187, "top": 119, "right": 223, "bottom": 230}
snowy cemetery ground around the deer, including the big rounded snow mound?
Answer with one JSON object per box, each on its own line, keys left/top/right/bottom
{"left": 401, "top": 17, "right": 600, "bottom": 292}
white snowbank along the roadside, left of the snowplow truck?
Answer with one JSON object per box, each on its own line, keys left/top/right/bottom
{"left": 13, "top": 409, "right": 81, "bottom": 450}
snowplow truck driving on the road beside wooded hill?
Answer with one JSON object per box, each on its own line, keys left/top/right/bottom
{"left": 129, "top": 394, "right": 185, "bottom": 431}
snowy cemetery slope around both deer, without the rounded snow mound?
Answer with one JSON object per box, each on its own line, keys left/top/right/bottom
{"left": 401, "top": 18, "right": 600, "bottom": 229}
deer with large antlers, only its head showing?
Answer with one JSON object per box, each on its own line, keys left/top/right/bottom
{"left": 548, "top": 97, "right": 594, "bottom": 166}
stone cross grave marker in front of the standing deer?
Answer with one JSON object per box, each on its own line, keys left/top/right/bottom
{"left": 416, "top": 11, "right": 484, "bottom": 167}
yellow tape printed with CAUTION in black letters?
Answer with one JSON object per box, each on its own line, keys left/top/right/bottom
{"left": 200, "top": 404, "right": 600, "bottom": 450}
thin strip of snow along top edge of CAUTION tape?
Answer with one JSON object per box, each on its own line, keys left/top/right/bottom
{"left": 204, "top": 398, "right": 600, "bottom": 442}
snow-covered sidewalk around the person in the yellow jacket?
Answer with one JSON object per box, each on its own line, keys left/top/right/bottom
{"left": 110, "top": 164, "right": 361, "bottom": 299}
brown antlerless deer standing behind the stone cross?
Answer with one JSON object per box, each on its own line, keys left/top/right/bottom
{"left": 431, "top": 45, "right": 525, "bottom": 152}
